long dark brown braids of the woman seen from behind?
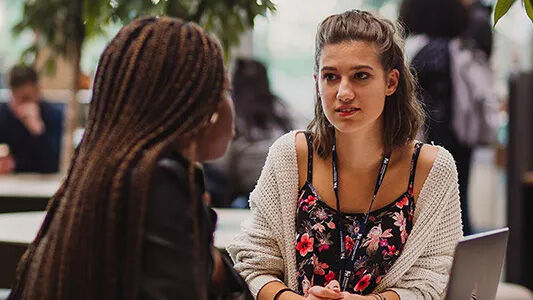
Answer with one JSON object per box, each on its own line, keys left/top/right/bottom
{"left": 10, "top": 17, "right": 227, "bottom": 299}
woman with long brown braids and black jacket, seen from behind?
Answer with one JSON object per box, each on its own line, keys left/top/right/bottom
{"left": 10, "top": 17, "right": 247, "bottom": 299}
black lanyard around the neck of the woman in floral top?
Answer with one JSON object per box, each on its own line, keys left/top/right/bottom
{"left": 331, "top": 137, "right": 390, "bottom": 291}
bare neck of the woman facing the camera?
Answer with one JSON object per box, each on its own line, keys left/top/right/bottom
{"left": 336, "top": 121, "right": 384, "bottom": 172}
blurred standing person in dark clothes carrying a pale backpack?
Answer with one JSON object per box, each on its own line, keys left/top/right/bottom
{"left": 400, "top": 0, "right": 497, "bottom": 235}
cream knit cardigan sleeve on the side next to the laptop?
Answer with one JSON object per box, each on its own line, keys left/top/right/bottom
{"left": 389, "top": 149, "right": 463, "bottom": 300}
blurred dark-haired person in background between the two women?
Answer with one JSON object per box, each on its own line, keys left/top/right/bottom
{"left": 207, "top": 58, "right": 295, "bottom": 208}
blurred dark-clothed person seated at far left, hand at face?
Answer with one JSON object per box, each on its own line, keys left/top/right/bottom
{"left": 0, "top": 66, "right": 63, "bottom": 173}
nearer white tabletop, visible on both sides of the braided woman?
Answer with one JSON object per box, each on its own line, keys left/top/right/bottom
{"left": 0, "top": 208, "right": 250, "bottom": 248}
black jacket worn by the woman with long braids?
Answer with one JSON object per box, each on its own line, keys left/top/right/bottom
{"left": 139, "top": 154, "right": 249, "bottom": 299}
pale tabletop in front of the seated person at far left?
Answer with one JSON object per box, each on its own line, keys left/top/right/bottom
{"left": 0, "top": 174, "right": 63, "bottom": 199}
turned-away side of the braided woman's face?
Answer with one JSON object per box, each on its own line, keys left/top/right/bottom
{"left": 197, "top": 92, "right": 235, "bottom": 161}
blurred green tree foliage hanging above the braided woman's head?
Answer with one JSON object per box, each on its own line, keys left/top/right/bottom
{"left": 15, "top": 0, "right": 276, "bottom": 65}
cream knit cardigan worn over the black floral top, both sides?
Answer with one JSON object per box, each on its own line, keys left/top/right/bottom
{"left": 227, "top": 131, "right": 463, "bottom": 300}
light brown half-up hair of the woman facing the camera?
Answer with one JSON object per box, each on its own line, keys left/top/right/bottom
{"left": 307, "top": 10, "right": 424, "bottom": 158}
